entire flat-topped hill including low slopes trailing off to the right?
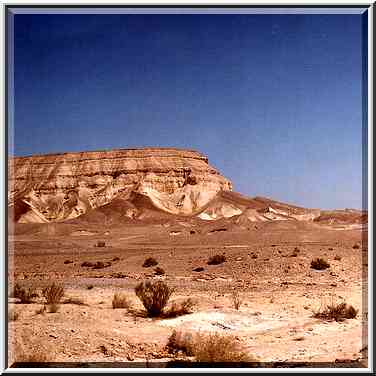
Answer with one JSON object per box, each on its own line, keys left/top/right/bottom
{"left": 8, "top": 148, "right": 368, "bottom": 227}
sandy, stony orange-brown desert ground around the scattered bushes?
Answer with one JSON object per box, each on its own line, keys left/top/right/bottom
{"left": 8, "top": 221, "right": 368, "bottom": 367}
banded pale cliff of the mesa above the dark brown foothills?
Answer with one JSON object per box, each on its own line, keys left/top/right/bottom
{"left": 8, "top": 148, "right": 232, "bottom": 222}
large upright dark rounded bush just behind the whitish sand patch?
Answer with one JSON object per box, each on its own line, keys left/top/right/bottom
{"left": 135, "top": 281, "right": 173, "bottom": 317}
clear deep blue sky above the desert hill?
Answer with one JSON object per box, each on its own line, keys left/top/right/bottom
{"left": 10, "top": 14, "right": 368, "bottom": 209}
